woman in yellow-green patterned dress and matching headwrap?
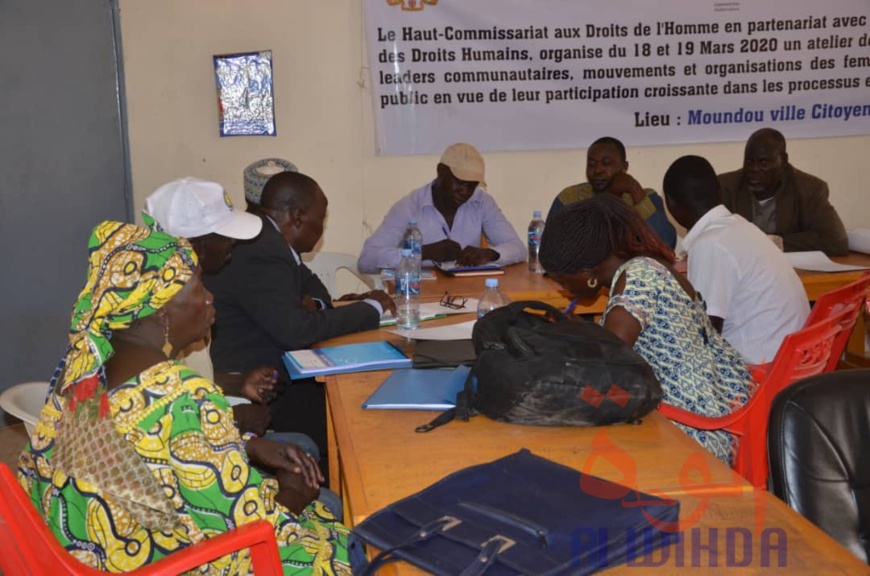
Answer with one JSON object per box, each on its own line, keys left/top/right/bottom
{"left": 19, "top": 222, "right": 350, "bottom": 575}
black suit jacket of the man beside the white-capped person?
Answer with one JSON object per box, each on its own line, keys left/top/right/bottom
{"left": 203, "top": 216, "right": 380, "bottom": 372}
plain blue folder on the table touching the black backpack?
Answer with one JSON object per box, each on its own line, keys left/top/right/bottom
{"left": 362, "top": 366, "right": 471, "bottom": 410}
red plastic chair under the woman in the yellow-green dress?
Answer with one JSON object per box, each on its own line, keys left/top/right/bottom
{"left": 0, "top": 464, "right": 284, "bottom": 576}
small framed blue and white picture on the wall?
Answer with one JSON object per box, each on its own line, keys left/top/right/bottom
{"left": 214, "top": 50, "right": 276, "bottom": 136}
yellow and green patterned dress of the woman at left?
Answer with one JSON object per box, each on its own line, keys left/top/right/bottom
{"left": 19, "top": 361, "right": 350, "bottom": 575}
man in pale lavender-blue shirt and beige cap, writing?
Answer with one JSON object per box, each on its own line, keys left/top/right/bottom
{"left": 357, "top": 143, "right": 526, "bottom": 274}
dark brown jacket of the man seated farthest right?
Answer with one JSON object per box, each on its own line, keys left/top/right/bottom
{"left": 719, "top": 165, "right": 849, "bottom": 256}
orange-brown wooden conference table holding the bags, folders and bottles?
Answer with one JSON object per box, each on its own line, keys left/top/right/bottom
{"left": 322, "top": 256, "right": 870, "bottom": 575}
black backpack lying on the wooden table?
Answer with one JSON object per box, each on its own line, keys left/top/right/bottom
{"left": 417, "top": 302, "right": 662, "bottom": 432}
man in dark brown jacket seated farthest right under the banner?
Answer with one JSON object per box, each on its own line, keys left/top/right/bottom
{"left": 719, "top": 128, "right": 849, "bottom": 256}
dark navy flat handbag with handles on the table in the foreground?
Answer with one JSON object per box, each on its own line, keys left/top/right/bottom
{"left": 352, "top": 449, "right": 680, "bottom": 576}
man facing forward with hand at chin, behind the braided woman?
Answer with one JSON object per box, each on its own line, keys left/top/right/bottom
{"left": 547, "top": 136, "right": 677, "bottom": 248}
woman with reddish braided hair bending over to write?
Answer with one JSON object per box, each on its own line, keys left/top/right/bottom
{"left": 540, "top": 194, "right": 752, "bottom": 464}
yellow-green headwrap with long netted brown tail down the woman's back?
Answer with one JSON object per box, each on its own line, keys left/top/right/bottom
{"left": 51, "top": 222, "right": 197, "bottom": 531}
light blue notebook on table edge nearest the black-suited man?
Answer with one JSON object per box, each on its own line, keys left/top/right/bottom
{"left": 281, "top": 341, "right": 411, "bottom": 378}
